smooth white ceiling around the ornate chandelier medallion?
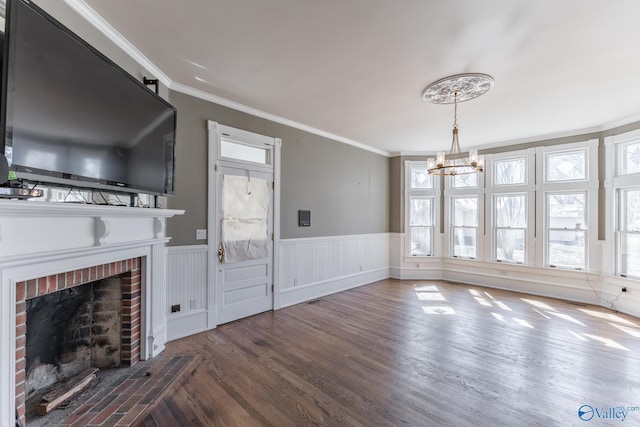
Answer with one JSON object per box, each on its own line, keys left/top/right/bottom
{"left": 79, "top": 0, "right": 640, "bottom": 155}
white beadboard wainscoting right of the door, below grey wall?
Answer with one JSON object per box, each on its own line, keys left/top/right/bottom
{"left": 276, "top": 233, "right": 390, "bottom": 308}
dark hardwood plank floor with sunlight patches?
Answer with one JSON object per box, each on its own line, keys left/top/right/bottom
{"left": 140, "top": 280, "right": 640, "bottom": 427}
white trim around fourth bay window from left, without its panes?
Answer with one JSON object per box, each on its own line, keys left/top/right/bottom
{"left": 536, "top": 139, "right": 602, "bottom": 272}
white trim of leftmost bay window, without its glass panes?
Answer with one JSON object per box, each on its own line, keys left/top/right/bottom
{"left": 403, "top": 160, "right": 442, "bottom": 262}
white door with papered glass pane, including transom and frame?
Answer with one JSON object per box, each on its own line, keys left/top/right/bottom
{"left": 209, "top": 125, "right": 275, "bottom": 324}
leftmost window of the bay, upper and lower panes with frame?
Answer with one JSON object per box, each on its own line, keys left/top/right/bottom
{"left": 405, "top": 161, "right": 436, "bottom": 257}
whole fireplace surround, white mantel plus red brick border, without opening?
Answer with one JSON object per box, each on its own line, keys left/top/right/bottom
{"left": 0, "top": 200, "right": 184, "bottom": 427}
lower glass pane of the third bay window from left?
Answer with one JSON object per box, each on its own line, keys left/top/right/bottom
{"left": 493, "top": 194, "right": 527, "bottom": 263}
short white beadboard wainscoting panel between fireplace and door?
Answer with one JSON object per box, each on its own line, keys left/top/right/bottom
{"left": 167, "top": 245, "right": 209, "bottom": 340}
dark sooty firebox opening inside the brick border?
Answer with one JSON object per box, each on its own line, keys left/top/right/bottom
{"left": 26, "top": 276, "right": 122, "bottom": 398}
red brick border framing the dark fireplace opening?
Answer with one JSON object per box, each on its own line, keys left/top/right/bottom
{"left": 15, "top": 258, "right": 142, "bottom": 422}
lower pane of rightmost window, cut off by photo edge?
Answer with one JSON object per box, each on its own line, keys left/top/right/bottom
{"left": 619, "top": 188, "right": 640, "bottom": 278}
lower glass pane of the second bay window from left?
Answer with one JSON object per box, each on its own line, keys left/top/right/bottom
{"left": 451, "top": 196, "right": 478, "bottom": 258}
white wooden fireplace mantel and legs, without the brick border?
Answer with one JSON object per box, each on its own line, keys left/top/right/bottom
{"left": 0, "top": 200, "right": 184, "bottom": 427}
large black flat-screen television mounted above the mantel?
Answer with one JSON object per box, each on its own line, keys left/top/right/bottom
{"left": 0, "top": 0, "right": 176, "bottom": 195}
